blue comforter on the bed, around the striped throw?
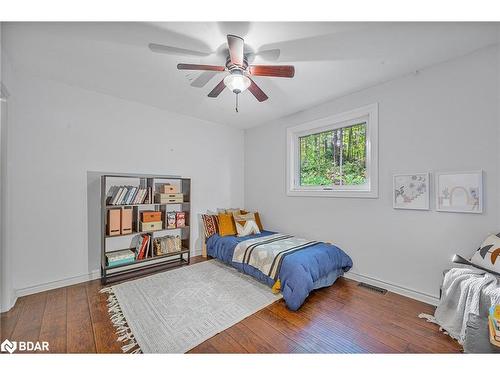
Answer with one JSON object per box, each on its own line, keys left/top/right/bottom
{"left": 207, "top": 231, "right": 352, "bottom": 310}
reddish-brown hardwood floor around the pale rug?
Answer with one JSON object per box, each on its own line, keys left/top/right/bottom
{"left": 1, "top": 257, "right": 461, "bottom": 353}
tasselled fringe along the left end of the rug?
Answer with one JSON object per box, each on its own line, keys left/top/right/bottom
{"left": 100, "top": 287, "right": 142, "bottom": 354}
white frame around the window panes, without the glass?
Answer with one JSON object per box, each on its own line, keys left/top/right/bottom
{"left": 286, "top": 103, "right": 378, "bottom": 198}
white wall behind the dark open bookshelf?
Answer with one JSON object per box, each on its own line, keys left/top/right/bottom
{"left": 5, "top": 67, "right": 244, "bottom": 294}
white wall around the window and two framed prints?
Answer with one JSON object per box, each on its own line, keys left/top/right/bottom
{"left": 245, "top": 48, "right": 500, "bottom": 306}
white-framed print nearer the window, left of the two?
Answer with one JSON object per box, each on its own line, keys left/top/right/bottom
{"left": 392, "top": 173, "right": 430, "bottom": 210}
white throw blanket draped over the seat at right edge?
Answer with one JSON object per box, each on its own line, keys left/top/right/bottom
{"left": 419, "top": 268, "right": 500, "bottom": 345}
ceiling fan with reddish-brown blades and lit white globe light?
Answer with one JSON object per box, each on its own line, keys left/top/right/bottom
{"left": 149, "top": 34, "right": 295, "bottom": 112}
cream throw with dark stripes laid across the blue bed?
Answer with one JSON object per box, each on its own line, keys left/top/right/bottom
{"left": 233, "top": 233, "right": 319, "bottom": 280}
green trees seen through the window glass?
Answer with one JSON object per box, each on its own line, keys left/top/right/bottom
{"left": 299, "top": 122, "right": 366, "bottom": 186}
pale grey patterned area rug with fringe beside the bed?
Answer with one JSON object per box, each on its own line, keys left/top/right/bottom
{"left": 101, "top": 260, "right": 281, "bottom": 353}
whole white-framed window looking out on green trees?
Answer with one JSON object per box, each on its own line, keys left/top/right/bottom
{"left": 287, "top": 104, "right": 378, "bottom": 198}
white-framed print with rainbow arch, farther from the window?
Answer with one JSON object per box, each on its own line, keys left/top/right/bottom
{"left": 436, "top": 170, "right": 483, "bottom": 214}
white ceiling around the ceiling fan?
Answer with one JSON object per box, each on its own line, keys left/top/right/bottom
{"left": 3, "top": 22, "right": 498, "bottom": 128}
